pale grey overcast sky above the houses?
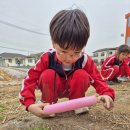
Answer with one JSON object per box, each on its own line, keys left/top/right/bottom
{"left": 0, "top": 0, "right": 130, "bottom": 55}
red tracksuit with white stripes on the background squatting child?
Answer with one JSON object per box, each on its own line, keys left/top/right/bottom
{"left": 101, "top": 54, "right": 130, "bottom": 80}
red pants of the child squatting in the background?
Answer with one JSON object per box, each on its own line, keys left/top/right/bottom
{"left": 101, "top": 65, "right": 126, "bottom": 80}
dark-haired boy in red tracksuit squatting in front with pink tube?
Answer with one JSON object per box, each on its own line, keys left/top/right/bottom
{"left": 20, "top": 9, "right": 115, "bottom": 117}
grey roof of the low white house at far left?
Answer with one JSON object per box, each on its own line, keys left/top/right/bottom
{"left": 0, "top": 52, "right": 27, "bottom": 58}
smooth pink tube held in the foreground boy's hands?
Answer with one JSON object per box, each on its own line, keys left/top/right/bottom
{"left": 44, "top": 96, "right": 97, "bottom": 115}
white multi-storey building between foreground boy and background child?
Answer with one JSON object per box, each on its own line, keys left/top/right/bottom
{"left": 92, "top": 47, "right": 117, "bottom": 65}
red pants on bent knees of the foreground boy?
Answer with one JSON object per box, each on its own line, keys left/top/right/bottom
{"left": 38, "top": 69, "right": 90, "bottom": 103}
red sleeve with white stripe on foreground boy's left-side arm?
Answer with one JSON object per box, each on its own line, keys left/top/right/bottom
{"left": 19, "top": 53, "right": 48, "bottom": 110}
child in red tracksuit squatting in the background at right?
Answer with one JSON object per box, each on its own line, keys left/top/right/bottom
{"left": 101, "top": 45, "right": 130, "bottom": 84}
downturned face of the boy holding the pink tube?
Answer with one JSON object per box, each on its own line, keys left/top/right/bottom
{"left": 53, "top": 44, "right": 84, "bottom": 65}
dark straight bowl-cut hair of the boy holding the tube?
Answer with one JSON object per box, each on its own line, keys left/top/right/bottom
{"left": 50, "top": 9, "right": 90, "bottom": 50}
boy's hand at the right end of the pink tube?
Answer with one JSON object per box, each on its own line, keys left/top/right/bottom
{"left": 98, "top": 95, "right": 114, "bottom": 110}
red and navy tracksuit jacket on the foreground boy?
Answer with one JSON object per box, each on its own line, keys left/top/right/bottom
{"left": 19, "top": 51, "right": 115, "bottom": 107}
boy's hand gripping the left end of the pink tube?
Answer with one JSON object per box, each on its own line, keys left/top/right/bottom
{"left": 28, "top": 103, "right": 49, "bottom": 117}
